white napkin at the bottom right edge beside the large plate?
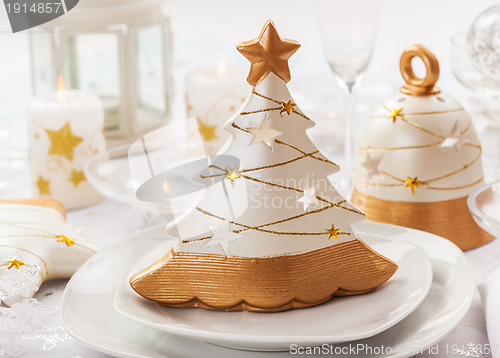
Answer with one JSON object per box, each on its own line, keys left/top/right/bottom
{"left": 478, "top": 267, "right": 500, "bottom": 358}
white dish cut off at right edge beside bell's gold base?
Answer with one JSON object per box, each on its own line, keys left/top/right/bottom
{"left": 467, "top": 181, "right": 500, "bottom": 237}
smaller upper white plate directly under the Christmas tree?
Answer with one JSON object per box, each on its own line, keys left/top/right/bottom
{"left": 115, "top": 233, "right": 432, "bottom": 351}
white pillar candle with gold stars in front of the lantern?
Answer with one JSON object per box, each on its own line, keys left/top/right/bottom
{"left": 28, "top": 81, "right": 105, "bottom": 210}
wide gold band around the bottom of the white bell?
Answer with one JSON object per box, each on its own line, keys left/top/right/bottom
{"left": 351, "top": 189, "right": 494, "bottom": 251}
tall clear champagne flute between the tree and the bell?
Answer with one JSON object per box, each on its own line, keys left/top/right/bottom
{"left": 316, "top": 0, "right": 381, "bottom": 193}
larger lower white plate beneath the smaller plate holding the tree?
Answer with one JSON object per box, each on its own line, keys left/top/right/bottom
{"left": 61, "top": 222, "right": 474, "bottom": 358}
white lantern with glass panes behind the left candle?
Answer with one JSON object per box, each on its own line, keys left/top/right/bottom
{"left": 30, "top": 0, "right": 172, "bottom": 142}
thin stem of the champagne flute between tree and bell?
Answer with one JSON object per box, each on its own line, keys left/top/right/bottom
{"left": 343, "top": 89, "right": 358, "bottom": 192}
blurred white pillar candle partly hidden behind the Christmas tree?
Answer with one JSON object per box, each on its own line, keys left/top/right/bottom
{"left": 186, "top": 60, "right": 251, "bottom": 154}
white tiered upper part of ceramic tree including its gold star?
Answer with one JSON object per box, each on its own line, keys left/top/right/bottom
{"left": 166, "top": 23, "right": 364, "bottom": 257}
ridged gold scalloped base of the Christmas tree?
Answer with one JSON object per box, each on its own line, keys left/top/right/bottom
{"left": 130, "top": 239, "right": 397, "bottom": 312}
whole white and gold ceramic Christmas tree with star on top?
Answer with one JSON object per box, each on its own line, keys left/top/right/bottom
{"left": 130, "top": 21, "right": 397, "bottom": 312}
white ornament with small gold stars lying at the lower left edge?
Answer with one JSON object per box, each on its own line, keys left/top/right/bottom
{"left": 0, "top": 199, "right": 98, "bottom": 306}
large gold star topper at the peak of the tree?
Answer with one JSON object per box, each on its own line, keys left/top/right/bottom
{"left": 237, "top": 20, "right": 300, "bottom": 86}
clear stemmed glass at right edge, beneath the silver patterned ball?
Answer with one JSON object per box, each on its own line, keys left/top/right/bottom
{"left": 450, "top": 31, "right": 500, "bottom": 179}
